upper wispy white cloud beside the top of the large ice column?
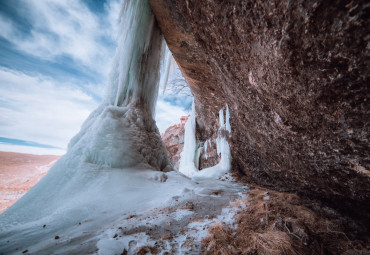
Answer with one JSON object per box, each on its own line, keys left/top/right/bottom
{"left": 0, "top": 0, "right": 119, "bottom": 76}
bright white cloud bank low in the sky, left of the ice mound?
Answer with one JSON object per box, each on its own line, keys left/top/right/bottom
{"left": 0, "top": 68, "right": 98, "bottom": 148}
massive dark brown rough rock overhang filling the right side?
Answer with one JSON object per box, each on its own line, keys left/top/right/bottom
{"left": 150, "top": 0, "right": 370, "bottom": 225}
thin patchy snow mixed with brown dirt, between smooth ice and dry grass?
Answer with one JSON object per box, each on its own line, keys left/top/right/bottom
{"left": 97, "top": 176, "right": 248, "bottom": 255}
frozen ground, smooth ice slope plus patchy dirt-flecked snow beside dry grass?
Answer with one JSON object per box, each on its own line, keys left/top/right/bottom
{"left": 0, "top": 164, "right": 247, "bottom": 254}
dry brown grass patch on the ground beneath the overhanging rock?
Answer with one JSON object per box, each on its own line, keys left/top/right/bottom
{"left": 202, "top": 188, "right": 370, "bottom": 255}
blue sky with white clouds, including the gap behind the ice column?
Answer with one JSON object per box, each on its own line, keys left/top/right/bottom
{"left": 0, "top": 0, "right": 192, "bottom": 154}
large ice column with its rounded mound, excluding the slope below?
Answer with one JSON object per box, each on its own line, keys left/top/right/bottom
{"left": 69, "top": 0, "right": 171, "bottom": 170}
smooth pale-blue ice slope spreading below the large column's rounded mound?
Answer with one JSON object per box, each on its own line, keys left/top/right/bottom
{"left": 0, "top": 161, "right": 194, "bottom": 254}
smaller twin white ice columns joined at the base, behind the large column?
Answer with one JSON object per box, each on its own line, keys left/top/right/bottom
{"left": 179, "top": 103, "right": 231, "bottom": 177}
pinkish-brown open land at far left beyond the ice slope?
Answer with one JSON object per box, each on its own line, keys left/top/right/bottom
{"left": 0, "top": 152, "right": 59, "bottom": 213}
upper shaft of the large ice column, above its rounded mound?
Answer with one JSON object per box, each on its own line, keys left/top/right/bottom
{"left": 105, "top": 0, "right": 163, "bottom": 116}
